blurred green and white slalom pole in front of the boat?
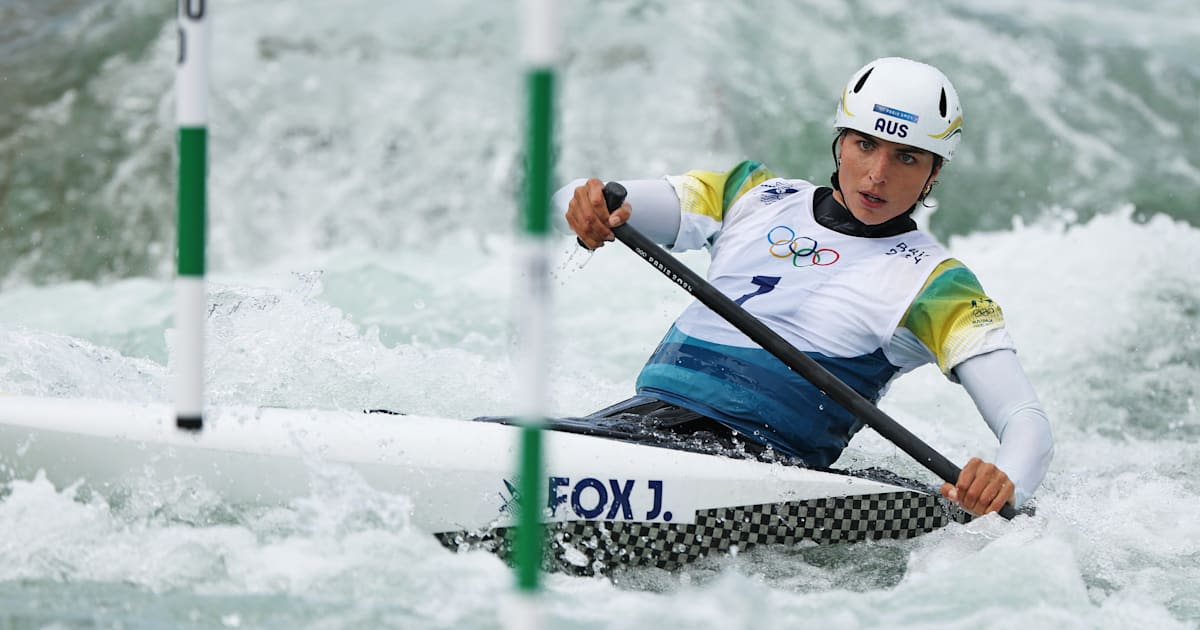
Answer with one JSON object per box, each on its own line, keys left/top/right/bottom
{"left": 510, "top": 0, "right": 557, "bottom": 628}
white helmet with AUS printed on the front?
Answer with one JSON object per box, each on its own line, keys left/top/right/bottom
{"left": 833, "top": 56, "right": 962, "bottom": 162}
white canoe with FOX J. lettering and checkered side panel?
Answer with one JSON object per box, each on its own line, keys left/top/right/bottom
{"left": 0, "top": 397, "right": 964, "bottom": 574}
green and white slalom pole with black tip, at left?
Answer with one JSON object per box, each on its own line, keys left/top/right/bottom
{"left": 175, "top": 0, "right": 209, "bottom": 431}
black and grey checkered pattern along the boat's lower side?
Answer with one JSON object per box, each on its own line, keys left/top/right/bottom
{"left": 437, "top": 492, "right": 971, "bottom": 575}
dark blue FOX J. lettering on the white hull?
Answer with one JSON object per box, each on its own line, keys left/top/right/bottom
{"left": 546, "top": 476, "right": 673, "bottom": 521}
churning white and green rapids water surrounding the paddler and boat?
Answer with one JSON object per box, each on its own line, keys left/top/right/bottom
{"left": 0, "top": 0, "right": 1200, "bottom": 629}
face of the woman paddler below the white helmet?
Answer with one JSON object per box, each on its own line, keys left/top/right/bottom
{"left": 834, "top": 130, "right": 940, "bottom": 226}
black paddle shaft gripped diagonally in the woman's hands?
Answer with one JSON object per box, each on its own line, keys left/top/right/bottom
{"left": 604, "top": 181, "right": 1016, "bottom": 518}
